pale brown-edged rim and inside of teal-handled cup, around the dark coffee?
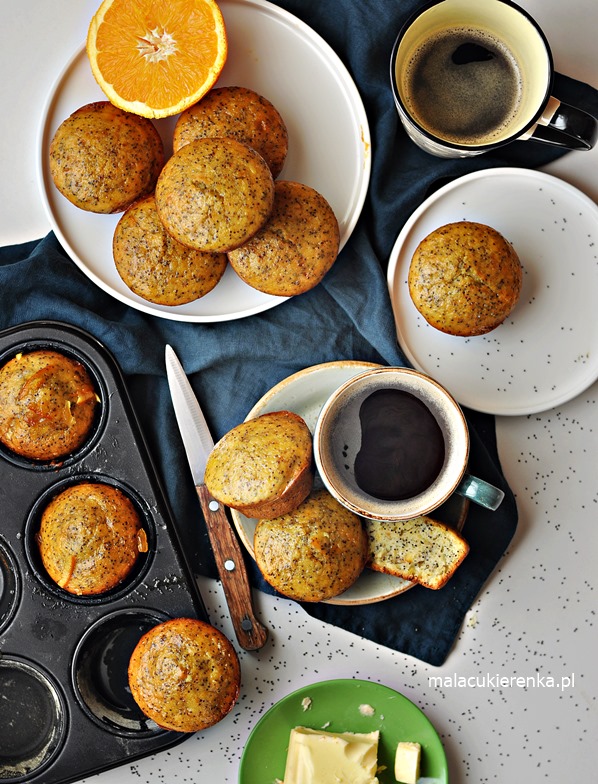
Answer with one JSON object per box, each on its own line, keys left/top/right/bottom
{"left": 314, "top": 367, "right": 469, "bottom": 520}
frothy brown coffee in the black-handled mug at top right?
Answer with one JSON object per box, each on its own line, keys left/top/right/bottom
{"left": 404, "top": 28, "right": 522, "bottom": 145}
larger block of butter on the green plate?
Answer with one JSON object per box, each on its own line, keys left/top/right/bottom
{"left": 284, "top": 727, "right": 380, "bottom": 784}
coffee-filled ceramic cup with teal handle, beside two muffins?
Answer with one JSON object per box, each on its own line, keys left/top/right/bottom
{"left": 314, "top": 367, "right": 504, "bottom": 520}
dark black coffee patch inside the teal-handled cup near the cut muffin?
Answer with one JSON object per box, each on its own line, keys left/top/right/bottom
{"left": 354, "top": 389, "right": 444, "bottom": 501}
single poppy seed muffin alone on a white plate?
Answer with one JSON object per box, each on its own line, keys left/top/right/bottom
{"left": 408, "top": 221, "right": 523, "bottom": 337}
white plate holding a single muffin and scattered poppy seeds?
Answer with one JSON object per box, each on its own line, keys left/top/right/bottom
{"left": 388, "top": 168, "right": 598, "bottom": 415}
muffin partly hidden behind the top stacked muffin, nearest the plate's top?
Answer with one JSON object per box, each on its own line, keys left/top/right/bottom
{"left": 173, "top": 87, "right": 289, "bottom": 178}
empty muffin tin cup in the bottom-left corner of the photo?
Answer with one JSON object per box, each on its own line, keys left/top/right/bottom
{"left": 0, "top": 654, "right": 67, "bottom": 782}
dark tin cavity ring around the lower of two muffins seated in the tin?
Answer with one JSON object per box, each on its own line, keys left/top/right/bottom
{"left": 25, "top": 474, "right": 156, "bottom": 604}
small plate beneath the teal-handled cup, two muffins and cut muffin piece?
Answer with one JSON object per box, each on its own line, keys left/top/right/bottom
{"left": 231, "top": 360, "right": 468, "bottom": 605}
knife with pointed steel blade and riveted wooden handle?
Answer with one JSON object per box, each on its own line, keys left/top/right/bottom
{"left": 165, "top": 346, "right": 268, "bottom": 651}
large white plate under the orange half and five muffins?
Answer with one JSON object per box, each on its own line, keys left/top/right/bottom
{"left": 38, "top": 0, "right": 371, "bottom": 322}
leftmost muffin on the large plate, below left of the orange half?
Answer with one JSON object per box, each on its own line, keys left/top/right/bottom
{"left": 50, "top": 101, "right": 164, "bottom": 213}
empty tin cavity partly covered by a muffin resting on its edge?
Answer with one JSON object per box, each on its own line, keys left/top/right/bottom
{"left": 72, "top": 609, "right": 167, "bottom": 735}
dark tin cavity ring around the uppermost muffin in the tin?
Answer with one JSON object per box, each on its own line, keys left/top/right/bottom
{"left": 0, "top": 339, "right": 109, "bottom": 471}
